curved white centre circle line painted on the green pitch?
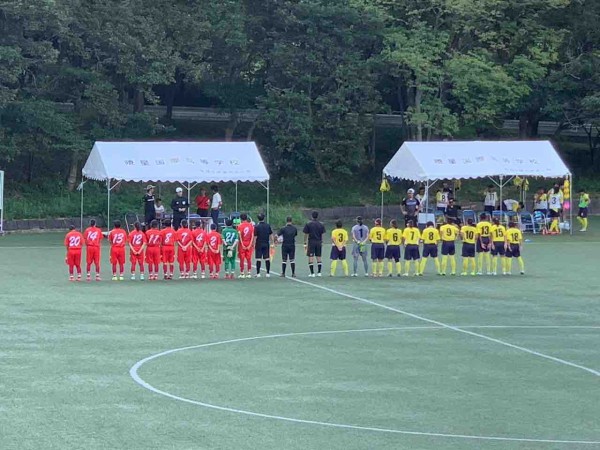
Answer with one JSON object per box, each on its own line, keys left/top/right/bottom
{"left": 129, "top": 325, "right": 600, "bottom": 445}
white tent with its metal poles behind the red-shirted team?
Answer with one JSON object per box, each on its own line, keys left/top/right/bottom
{"left": 81, "top": 141, "right": 270, "bottom": 229}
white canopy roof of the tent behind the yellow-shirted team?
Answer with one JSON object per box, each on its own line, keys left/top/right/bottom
{"left": 383, "top": 141, "right": 571, "bottom": 181}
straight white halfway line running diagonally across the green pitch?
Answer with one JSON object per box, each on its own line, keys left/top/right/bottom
{"left": 282, "top": 272, "right": 600, "bottom": 377}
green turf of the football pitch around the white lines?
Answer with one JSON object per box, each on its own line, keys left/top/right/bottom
{"left": 0, "top": 220, "right": 600, "bottom": 450}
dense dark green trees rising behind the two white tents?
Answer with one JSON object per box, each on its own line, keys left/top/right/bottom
{"left": 0, "top": 0, "right": 600, "bottom": 189}
